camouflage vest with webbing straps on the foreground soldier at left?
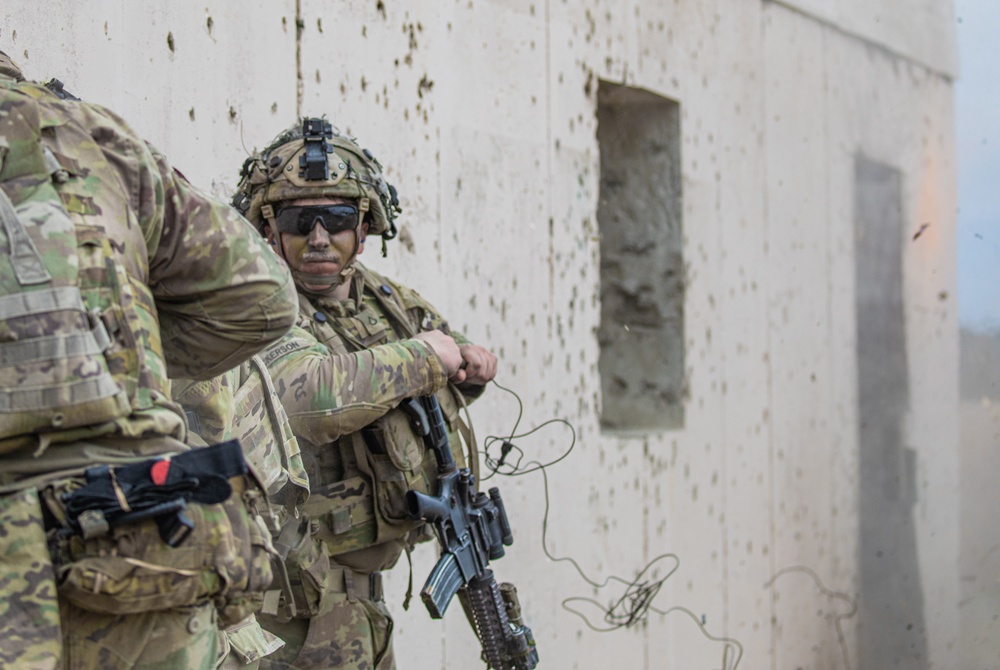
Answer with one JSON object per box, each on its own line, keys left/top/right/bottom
{"left": 0, "top": 80, "right": 149, "bottom": 453}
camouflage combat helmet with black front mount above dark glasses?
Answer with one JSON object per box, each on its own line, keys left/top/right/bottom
{"left": 233, "top": 118, "right": 400, "bottom": 245}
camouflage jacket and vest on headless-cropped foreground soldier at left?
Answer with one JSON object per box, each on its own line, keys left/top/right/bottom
{"left": 0, "top": 74, "right": 295, "bottom": 488}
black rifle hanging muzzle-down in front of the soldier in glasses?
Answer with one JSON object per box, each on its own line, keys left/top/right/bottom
{"left": 400, "top": 396, "right": 538, "bottom": 670}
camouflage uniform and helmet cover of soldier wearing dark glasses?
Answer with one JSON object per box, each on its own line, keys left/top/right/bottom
{"left": 234, "top": 122, "right": 482, "bottom": 670}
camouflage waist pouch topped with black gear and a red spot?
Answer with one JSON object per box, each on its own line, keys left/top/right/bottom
{"left": 46, "top": 442, "right": 274, "bottom": 625}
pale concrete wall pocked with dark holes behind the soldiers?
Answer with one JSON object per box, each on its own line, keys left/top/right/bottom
{"left": 0, "top": 0, "right": 960, "bottom": 670}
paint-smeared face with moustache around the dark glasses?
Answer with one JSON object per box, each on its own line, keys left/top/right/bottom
{"left": 270, "top": 197, "right": 359, "bottom": 291}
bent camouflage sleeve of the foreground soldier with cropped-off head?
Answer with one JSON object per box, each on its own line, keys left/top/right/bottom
{"left": 137, "top": 150, "right": 297, "bottom": 379}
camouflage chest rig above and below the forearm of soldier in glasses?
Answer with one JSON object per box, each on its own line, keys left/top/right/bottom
{"left": 300, "top": 265, "right": 472, "bottom": 556}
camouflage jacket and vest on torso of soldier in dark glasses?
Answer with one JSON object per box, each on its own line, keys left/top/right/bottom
{"left": 263, "top": 263, "right": 482, "bottom": 570}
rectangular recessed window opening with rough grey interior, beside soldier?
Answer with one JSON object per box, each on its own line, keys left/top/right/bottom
{"left": 597, "top": 81, "right": 684, "bottom": 432}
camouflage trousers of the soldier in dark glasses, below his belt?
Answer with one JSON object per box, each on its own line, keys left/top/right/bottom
{"left": 258, "top": 573, "right": 396, "bottom": 670}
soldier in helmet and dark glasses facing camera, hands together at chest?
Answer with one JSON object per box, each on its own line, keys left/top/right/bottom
{"left": 233, "top": 118, "right": 496, "bottom": 670}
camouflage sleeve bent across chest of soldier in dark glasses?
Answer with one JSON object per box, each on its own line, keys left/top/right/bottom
{"left": 263, "top": 326, "right": 447, "bottom": 444}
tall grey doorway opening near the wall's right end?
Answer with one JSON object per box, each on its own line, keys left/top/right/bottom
{"left": 854, "top": 155, "right": 930, "bottom": 670}
